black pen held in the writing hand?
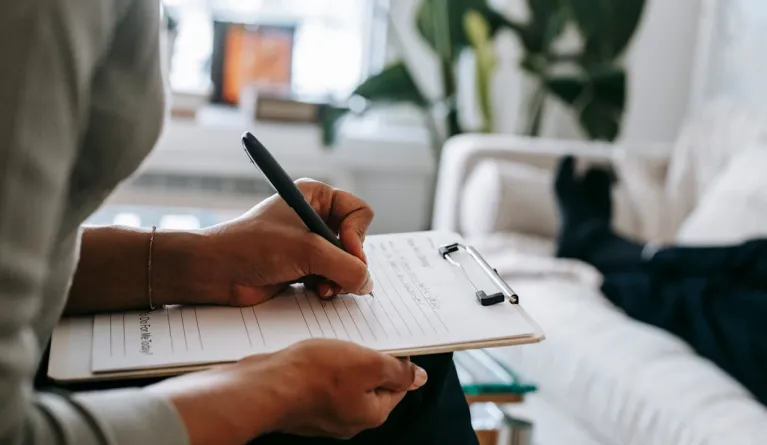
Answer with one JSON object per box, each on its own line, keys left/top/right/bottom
{"left": 242, "top": 131, "right": 374, "bottom": 297}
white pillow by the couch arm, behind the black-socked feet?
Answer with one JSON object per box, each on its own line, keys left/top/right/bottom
{"left": 459, "top": 159, "right": 639, "bottom": 238}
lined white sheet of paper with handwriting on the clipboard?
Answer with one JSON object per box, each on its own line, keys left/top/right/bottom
{"left": 91, "top": 232, "right": 534, "bottom": 373}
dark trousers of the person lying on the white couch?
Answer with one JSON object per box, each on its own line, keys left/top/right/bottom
{"left": 582, "top": 235, "right": 767, "bottom": 405}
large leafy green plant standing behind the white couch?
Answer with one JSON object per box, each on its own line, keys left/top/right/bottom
{"left": 322, "top": 0, "right": 644, "bottom": 161}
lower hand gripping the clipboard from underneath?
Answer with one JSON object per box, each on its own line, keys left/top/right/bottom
{"left": 148, "top": 340, "right": 426, "bottom": 444}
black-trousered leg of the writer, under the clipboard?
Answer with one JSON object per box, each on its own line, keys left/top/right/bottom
{"left": 251, "top": 354, "right": 477, "bottom": 445}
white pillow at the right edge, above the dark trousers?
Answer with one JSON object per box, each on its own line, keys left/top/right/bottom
{"left": 677, "top": 146, "right": 767, "bottom": 245}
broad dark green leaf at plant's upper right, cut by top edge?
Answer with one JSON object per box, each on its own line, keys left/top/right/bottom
{"left": 568, "top": 0, "right": 645, "bottom": 63}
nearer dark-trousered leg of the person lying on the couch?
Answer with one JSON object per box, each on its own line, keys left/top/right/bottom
{"left": 602, "top": 271, "right": 767, "bottom": 404}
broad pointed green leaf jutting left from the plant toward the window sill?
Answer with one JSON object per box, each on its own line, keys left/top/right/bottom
{"left": 352, "top": 61, "right": 429, "bottom": 107}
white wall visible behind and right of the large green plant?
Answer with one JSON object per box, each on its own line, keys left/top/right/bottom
{"left": 391, "top": 0, "right": 700, "bottom": 141}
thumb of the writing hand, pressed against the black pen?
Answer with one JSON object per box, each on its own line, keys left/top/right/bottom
{"left": 305, "top": 235, "right": 373, "bottom": 295}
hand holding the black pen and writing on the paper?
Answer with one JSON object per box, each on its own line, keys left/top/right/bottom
{"left": 178, "top": 179, "right": 373, "bottom": 306}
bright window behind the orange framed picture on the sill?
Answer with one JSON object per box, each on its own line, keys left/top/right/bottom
{"left": 163, "top": 0, "right": 386, "bottom": 97}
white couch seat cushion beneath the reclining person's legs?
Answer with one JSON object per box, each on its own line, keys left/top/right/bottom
{"left": 480, "top": 243, "right": 767, "bottom": 445}
